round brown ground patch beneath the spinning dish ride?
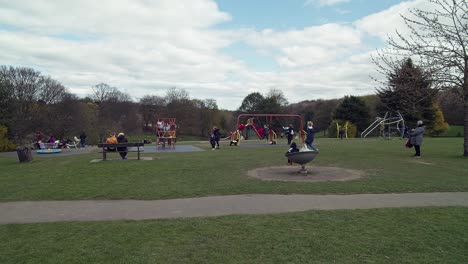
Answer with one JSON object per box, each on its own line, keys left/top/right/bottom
{"left": 247, "top": 165, "right": 365, "bottom": 182}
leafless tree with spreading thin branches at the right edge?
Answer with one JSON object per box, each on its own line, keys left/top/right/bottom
{"left": 375, "top": 0, "right": 468, "bottom": 156}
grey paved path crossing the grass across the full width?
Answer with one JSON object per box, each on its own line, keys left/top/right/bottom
{"left": 0, "top": 192, "right": 468, "bottom": 224}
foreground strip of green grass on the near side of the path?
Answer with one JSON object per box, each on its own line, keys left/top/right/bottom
{"left": 0, "top": 207, "right": 468, "bottom": 264}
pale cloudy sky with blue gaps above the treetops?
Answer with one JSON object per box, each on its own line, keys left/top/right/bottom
{"left": 0, "top": 0, "right": 429, "bottom": 110}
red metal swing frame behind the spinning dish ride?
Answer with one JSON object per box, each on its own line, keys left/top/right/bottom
{"left": 233, "top": 114, "right": 305, "bottom": 144}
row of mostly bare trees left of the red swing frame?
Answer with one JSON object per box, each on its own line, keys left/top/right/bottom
{"left": 0, "top": 66, "right": 232, "bottom": 144}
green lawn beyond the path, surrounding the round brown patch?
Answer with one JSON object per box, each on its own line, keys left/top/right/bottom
{"left": 0, "top": 138, "right": 468, "bottom": 201}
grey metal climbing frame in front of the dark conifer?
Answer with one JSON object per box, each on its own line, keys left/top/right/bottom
{"left": 361, "top": 111, "right": 407, "bottom": 139}
